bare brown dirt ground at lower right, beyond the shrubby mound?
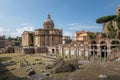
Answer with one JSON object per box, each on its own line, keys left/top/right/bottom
{"left": 51, "top": 62, "right": 120, "bottom": 80}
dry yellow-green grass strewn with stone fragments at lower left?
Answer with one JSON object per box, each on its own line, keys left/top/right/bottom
{"left": 0, "top": 53, "right": 49, "bottom": 80}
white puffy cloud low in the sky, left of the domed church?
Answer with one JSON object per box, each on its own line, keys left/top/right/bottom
{"left": 0, "top": 25, "right": 34, "bottom": 37}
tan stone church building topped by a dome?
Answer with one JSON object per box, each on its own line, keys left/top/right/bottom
{"left": 22, "top": 15, "right": 63, "bottom": 53}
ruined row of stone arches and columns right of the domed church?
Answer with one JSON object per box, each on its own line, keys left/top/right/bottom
{"left": 57, "top": 39, "right": 120, "bottom": 61}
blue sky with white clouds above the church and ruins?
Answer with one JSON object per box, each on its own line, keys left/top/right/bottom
{"left": 0, "top": 0, "right": 120, "bottom": 37}
